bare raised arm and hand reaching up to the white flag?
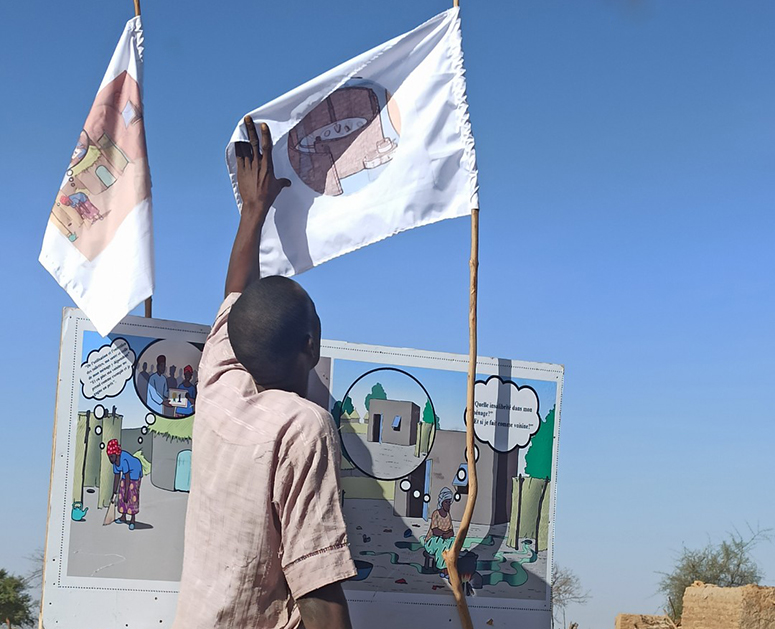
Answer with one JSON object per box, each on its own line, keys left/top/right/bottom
{"left": 226, "top": 116, "right": 291, "bottom": 295}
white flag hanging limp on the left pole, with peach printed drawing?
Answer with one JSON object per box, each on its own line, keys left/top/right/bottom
{"left": 40, "top": 17, "right": 153, "bottom": 336}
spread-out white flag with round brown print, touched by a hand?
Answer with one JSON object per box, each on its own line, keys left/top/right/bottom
{"left": 226, "top": 8, "right": 478, "bottom": 275}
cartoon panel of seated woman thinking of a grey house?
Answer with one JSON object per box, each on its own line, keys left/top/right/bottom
{"left": 329, "top": 359, "right": 557, "bottom": 601}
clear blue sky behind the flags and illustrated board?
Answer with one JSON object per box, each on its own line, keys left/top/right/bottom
{"left": 0, "top": 0, "right": 775, "bottom": 629}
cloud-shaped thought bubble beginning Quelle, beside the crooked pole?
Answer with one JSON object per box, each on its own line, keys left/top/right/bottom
{"left": 474, "top": 376, "right": 541, "bottom": 452}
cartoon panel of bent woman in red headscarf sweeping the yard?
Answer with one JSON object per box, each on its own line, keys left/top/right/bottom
{"left": 67, "top": 331, "right": 202, "bottom": 581}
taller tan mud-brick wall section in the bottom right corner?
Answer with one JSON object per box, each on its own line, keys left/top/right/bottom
{"left": 682, "top": 583, "right": 775, "bottom": 629}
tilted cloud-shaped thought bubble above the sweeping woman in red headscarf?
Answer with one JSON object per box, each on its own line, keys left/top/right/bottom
{"left": 80, "top": 338, "right": 135, "bottom": 400}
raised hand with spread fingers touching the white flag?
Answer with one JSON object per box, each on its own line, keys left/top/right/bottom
{"left": 234, "top": 116, "right": 291, "bottom": 222}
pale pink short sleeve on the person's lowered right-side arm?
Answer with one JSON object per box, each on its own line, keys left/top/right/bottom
{"left": 273, "top": 402, "right": 357, "bottom": 599}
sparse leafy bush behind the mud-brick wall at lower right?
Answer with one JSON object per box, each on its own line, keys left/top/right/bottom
{"left": 659, "top": 527, "right": 772, "bottom": 622}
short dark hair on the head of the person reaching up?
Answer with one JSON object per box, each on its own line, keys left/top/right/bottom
{"left": 228, "top": 275, "right": 318, "bottom": 383}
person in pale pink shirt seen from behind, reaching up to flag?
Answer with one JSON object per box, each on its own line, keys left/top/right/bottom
{"left": 173, "top": 117, "right": 356, "bottom": 629}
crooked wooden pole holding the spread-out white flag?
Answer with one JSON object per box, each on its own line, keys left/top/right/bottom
{"left": 442, "top": 0, "right": 479, "bottom": 629}
